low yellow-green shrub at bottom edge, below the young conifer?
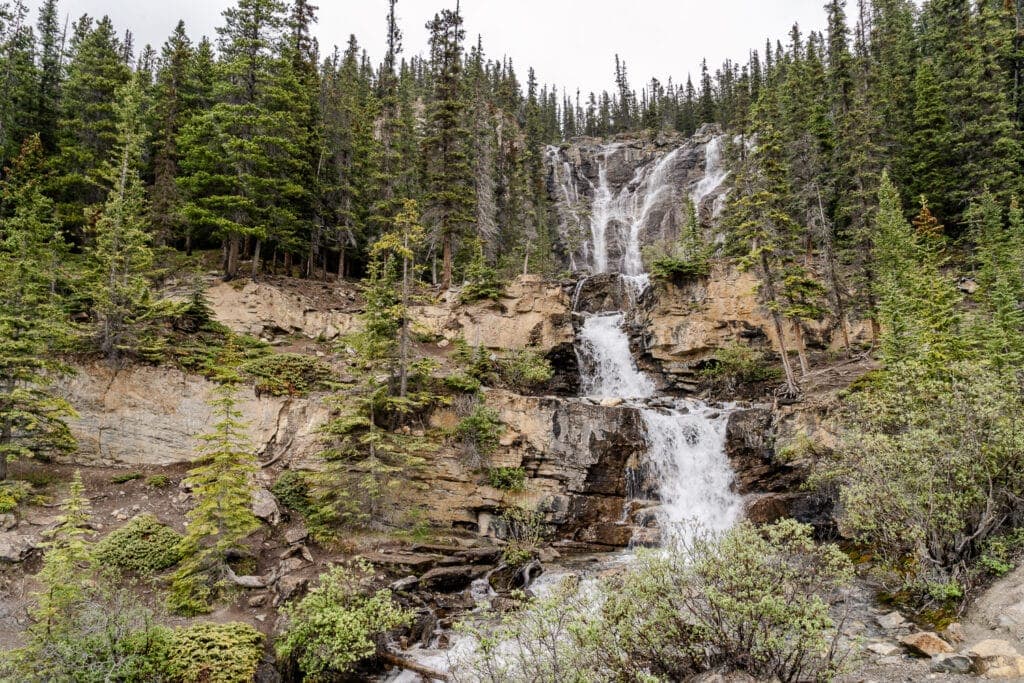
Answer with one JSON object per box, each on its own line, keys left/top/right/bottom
{"left": 167, "top": 623, "right": 263, "bottom": 683}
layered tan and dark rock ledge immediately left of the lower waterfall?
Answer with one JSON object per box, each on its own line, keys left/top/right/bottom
{"left": 411, "top": 390, "right": 645, "bottom": 547}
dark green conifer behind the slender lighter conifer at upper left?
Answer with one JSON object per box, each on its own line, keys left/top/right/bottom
{"left": 50, "top": 16, "right": 130, "bottom": 238}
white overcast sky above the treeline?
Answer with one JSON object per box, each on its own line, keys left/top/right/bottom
{"left": 30, "top": 0, "right": 825, "bottom": 93}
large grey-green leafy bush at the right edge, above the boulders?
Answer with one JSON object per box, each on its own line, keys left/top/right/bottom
{"left": 812, "top": 361, "right": 1024, "bottom": 607}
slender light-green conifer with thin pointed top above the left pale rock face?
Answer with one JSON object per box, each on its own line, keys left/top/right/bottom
{"left": 90, "top": 81, "right": 156, "bottom": 362}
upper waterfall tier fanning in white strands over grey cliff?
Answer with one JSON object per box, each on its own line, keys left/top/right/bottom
{"left": 546, "top": 126, "right": 728, "bottom": 275}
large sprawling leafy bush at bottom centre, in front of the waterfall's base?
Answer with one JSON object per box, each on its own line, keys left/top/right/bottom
{"left": 453, "top": 520, "right": 853, "bottom": 682}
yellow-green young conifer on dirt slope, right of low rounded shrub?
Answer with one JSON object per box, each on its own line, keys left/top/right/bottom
{"left": 168, "top": 384, "right": 259, "bottom": 614}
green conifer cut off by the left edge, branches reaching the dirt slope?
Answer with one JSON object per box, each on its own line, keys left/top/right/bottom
{"left": 0, "top": 137, "right": 76, "bottom": 480}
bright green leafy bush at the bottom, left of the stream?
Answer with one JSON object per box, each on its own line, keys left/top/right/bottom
{"left": 275, "top": 565, "right": 412, "bottom": 679}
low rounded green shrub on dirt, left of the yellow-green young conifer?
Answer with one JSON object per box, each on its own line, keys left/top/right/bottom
{"left": 93, "top": 514, "right": 181, "bottom": 573}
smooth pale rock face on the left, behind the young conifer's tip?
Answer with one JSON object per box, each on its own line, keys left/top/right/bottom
{"left": 60, "top": 362, "right": 327, "bottom": 467}
